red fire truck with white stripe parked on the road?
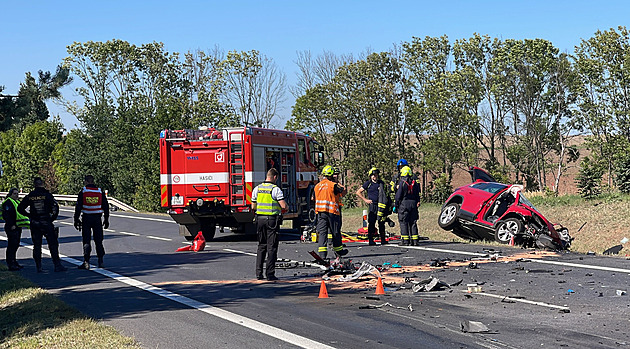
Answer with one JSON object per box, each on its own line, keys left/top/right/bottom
{"left": 160, "top": 127, "right": 323, "bottom": 240}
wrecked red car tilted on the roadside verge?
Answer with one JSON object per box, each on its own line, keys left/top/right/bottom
{"left": 438, "top": 167, "right": 573, "bottom": 250}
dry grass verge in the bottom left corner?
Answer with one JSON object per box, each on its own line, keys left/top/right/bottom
{"left": 0, "top": 265, "right": 140, "bottom": 349}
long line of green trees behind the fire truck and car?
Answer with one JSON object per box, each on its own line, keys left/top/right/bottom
{"left": 0, "top": 27, "right": 630, "bottom": 210}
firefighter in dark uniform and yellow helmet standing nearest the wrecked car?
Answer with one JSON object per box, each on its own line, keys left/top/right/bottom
{"left": 396, "top": 166, "right": 420, "bottom": 246}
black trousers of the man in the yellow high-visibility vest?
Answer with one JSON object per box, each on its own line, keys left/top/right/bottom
{"left": 256, "top": 215, "right": 280, "bottom": 278}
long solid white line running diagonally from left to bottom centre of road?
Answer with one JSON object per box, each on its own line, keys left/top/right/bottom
{"left": 0, "top": 236, "right": 334, "bottom": 349}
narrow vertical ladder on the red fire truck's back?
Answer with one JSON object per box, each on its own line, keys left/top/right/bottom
{"left": 228, "top": 131, "right": 247, "bottom": 206}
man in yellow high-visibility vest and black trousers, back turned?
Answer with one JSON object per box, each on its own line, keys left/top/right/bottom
{"left": 252, "top": 167, "right": 288, "bottom": 281}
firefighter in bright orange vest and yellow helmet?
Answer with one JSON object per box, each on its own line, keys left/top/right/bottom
{"left": 314, "top": 165, "right": 348, "bottom": 258}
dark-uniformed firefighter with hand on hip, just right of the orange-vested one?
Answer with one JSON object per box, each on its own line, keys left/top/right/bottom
{"left": 357, "top": 167, "right": 387, "bottom": 246}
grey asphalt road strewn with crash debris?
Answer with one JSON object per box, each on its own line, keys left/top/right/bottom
{"left": 0, "top": 208, "right": 630, "bottom": 348}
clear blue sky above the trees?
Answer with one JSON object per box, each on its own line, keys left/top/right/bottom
{"left": 0, "top": 0, "right": 630, "bottom": 128}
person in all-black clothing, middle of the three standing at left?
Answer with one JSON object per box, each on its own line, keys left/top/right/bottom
{"left": 17, "top": 177, "right": 66, "bottom": 273}
